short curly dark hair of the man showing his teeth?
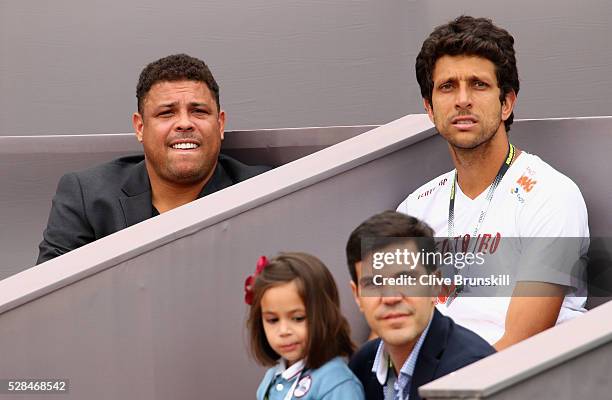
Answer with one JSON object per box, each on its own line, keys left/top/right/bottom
{"left": 136, "top": 54, "right": 221, "bottom": 114}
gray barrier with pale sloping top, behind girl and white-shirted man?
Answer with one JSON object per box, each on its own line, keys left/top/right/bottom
{"left": 0, "top": 115, "right": 612, "bottom": 399}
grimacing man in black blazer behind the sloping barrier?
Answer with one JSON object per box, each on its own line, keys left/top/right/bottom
{"left": 37, "top": 54, "right": 269, "bottom": 264}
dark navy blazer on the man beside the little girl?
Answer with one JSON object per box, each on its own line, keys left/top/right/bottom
{"left": 349, "top": 310, "right": 495, "bottom": 400}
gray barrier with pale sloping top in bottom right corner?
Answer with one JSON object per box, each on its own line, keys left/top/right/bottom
{"left": 419, "top": 302, "right": 612, "bottom": 400}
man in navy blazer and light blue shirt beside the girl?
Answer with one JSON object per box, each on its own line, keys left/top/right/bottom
{"left": 346, "top": 211, "right": 495, "bottom": 400}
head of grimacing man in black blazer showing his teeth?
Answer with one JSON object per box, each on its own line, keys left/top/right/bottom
{"left": 133, "top": 54, "right": 225, "bottom": 185}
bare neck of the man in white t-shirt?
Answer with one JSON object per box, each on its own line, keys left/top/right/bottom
{"left": 448, "top": 121, "right": 518, "bottom": 199}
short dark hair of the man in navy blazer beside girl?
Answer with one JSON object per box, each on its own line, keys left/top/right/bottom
{"left": 346, "top": 210, "right": 437, "bottom": 285}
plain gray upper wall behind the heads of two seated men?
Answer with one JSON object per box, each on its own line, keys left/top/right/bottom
{"left": 0, "top": 0, "right": 612, "bottom": 136}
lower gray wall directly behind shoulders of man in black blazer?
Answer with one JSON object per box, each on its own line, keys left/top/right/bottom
{"left": 0, "top": 126, "right": 375, "bottom": 280}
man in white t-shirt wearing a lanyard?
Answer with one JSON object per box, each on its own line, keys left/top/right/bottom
{"left": 397, "top": 16, "right": 589, "bottom": 350}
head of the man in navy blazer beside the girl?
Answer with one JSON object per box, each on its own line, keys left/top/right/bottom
{"left": 346, "top": 211, "right": 437, "bottom": 346}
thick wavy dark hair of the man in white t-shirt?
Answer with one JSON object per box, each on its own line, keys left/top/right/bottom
{"left": 415, "top": 15, "right": 519, "bottom": 131}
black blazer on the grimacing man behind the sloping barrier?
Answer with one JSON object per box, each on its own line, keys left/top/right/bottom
{"left": 36, "top": 154, "right": 270, "bottom": 264}
